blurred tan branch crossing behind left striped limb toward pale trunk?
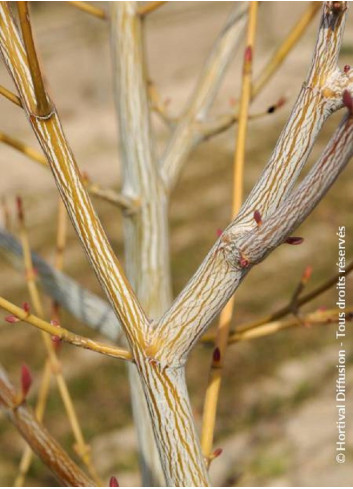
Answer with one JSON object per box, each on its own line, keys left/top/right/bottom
{"left": 0, "top": 132, "right": 139, "bottom": 214}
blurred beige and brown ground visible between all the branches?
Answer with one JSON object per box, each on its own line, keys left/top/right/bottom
{"left": 0, "top": 1, "right": 353, "bottom": 486}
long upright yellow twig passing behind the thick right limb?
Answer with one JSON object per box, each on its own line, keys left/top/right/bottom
{"left": 201, "top": 1, "right": 258, "bottom": 462}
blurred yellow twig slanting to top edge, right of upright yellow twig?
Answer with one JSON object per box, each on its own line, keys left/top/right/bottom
{"left": 251, "top": 2, "right": 321, "bottom": 98}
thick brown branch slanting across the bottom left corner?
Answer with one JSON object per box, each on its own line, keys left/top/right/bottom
{"left": 0, "top": 365, "right": 95, "bottom": 487}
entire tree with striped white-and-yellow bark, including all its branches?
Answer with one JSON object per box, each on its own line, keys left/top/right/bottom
{"left": 0, "top": 2, "right": 353, "bottom": 487}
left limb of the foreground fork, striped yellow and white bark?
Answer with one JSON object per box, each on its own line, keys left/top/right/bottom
{"left": 0, "top": 2, "right": 150, "bottom": 351}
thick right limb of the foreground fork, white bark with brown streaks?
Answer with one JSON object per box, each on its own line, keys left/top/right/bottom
{"left": 153, "top": 3, "right": 352, "bottom": 365}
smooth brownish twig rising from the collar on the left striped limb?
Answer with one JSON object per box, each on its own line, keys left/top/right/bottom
{"left": 17, "top": 2, "right": 52, "bottom": 117}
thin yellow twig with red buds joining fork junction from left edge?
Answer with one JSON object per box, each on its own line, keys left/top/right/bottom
{"left": 0, "top": 297, "right": 132, "bottom": 360}
